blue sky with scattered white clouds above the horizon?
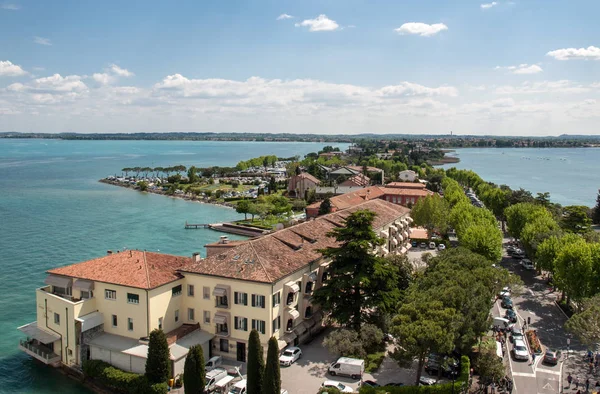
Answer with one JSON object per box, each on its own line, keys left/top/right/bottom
{"left": 0, "top": 0, "right": 600, "bottom": 136}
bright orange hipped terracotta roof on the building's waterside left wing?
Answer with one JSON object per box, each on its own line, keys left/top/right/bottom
{"left": 47, "top": 250, "right": 192, "bottom": 289}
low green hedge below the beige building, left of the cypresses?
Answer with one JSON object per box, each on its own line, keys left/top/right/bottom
{"left": 82, "top": 360, "right": 169, "bottom": 394}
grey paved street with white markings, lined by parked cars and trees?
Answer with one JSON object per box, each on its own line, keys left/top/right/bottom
{"left": 494, "top": 240, "right": 598, "bottom": 394}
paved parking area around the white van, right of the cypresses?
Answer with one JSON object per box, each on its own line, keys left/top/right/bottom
{"left": 281, "top": 330, "right": 426, "bottom": 394}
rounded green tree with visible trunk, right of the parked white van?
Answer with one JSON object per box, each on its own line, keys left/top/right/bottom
{"left": 392, "top": 298, "right": 456, "bottom": 385}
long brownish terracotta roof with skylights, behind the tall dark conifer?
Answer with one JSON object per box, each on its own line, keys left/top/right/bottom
{"left": 180, "top": 199, "right": 410, "bottom": 283}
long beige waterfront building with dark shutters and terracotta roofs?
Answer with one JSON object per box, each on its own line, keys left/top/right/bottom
{"left": 19, "top": 199, "right": 412, "bottom": 376}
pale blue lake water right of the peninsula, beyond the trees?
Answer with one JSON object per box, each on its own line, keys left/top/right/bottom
{"left": 443, "top": 148, "right": 600, "bottom": 207}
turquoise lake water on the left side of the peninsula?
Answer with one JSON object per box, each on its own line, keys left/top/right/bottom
{"left": 0, "top": 139, "right": 347, "bottom": 394}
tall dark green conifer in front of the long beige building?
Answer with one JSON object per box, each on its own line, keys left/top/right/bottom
{"left": 313, "top": 210, "right": 400, "bottom": 330}
